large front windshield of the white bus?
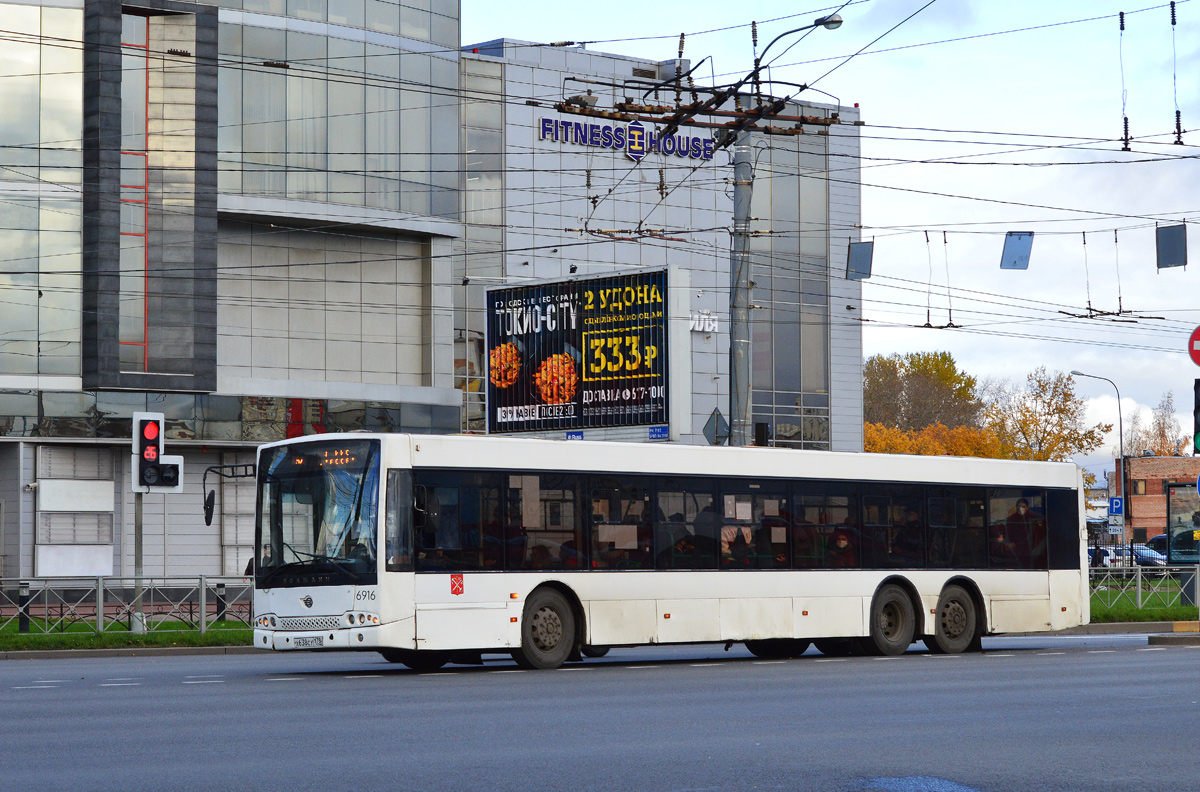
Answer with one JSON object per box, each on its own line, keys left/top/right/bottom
{"left": 254, "top": 439, "right": 379, "bottom": 588}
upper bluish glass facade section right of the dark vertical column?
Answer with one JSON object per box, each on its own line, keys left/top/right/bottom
{"left": 218, "top": 0, "right": 458, "bottom": 217}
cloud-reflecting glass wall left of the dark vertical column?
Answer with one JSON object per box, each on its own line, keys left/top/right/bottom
{"left": 0, "top": 4, "right": 83, "bottom": 377}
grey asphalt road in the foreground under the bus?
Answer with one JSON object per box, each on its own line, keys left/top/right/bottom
{"left": 0, "top": 635, "right": 1200, "bottom": 792}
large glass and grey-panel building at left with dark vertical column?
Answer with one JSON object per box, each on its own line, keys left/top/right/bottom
{"left": 0, "top": 0, "right": 463, "bottom": 577}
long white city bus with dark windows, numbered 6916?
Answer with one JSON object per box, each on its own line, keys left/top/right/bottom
{"left": 254, "top": 433, "right": 1090, "bottom": 670}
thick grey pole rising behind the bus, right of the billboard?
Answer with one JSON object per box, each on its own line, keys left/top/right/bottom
{"left": 730, "top": 131, "right": 754, "bottom": 445}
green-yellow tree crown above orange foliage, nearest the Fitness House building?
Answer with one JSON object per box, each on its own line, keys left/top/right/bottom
{"left": 863, "top": 352, "right": 983, "bottom": 432}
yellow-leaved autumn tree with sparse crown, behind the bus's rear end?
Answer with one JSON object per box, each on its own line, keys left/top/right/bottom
{"left": 984, "top": 366, "right": 1112, "bottom": 462}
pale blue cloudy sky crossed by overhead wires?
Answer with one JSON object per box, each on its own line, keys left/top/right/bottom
{"left": 462, "top": 0, "right": 1200, "bottom": 473}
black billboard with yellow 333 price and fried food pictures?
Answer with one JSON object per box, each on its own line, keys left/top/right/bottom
{"left": 487, "top": 269, "right": 667, "bottom": 433}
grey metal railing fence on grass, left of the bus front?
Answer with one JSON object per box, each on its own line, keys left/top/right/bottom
{"left": 0, "top": 575, "right": 254, "bottom": 635}
